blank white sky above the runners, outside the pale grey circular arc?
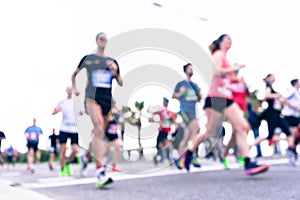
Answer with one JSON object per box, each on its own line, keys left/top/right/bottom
{"left": 0, "top": 0, "right": 300, "bottom": 152}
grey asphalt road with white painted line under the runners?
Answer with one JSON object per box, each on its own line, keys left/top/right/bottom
{"left": 0, "top": 157, "right": 300, "bottom": 200}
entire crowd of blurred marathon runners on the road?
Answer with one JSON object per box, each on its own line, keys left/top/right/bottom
{"left": 0, "top": 33, "right": 300, "bottom": 188}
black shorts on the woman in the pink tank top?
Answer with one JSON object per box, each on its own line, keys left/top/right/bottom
{"left": 203, "top": 97, "right": 234, "bottom": 113}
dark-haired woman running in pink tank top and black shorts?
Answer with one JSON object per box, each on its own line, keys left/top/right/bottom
{"left": 184, "top": 34, "right": 269, "bottom": 175}
